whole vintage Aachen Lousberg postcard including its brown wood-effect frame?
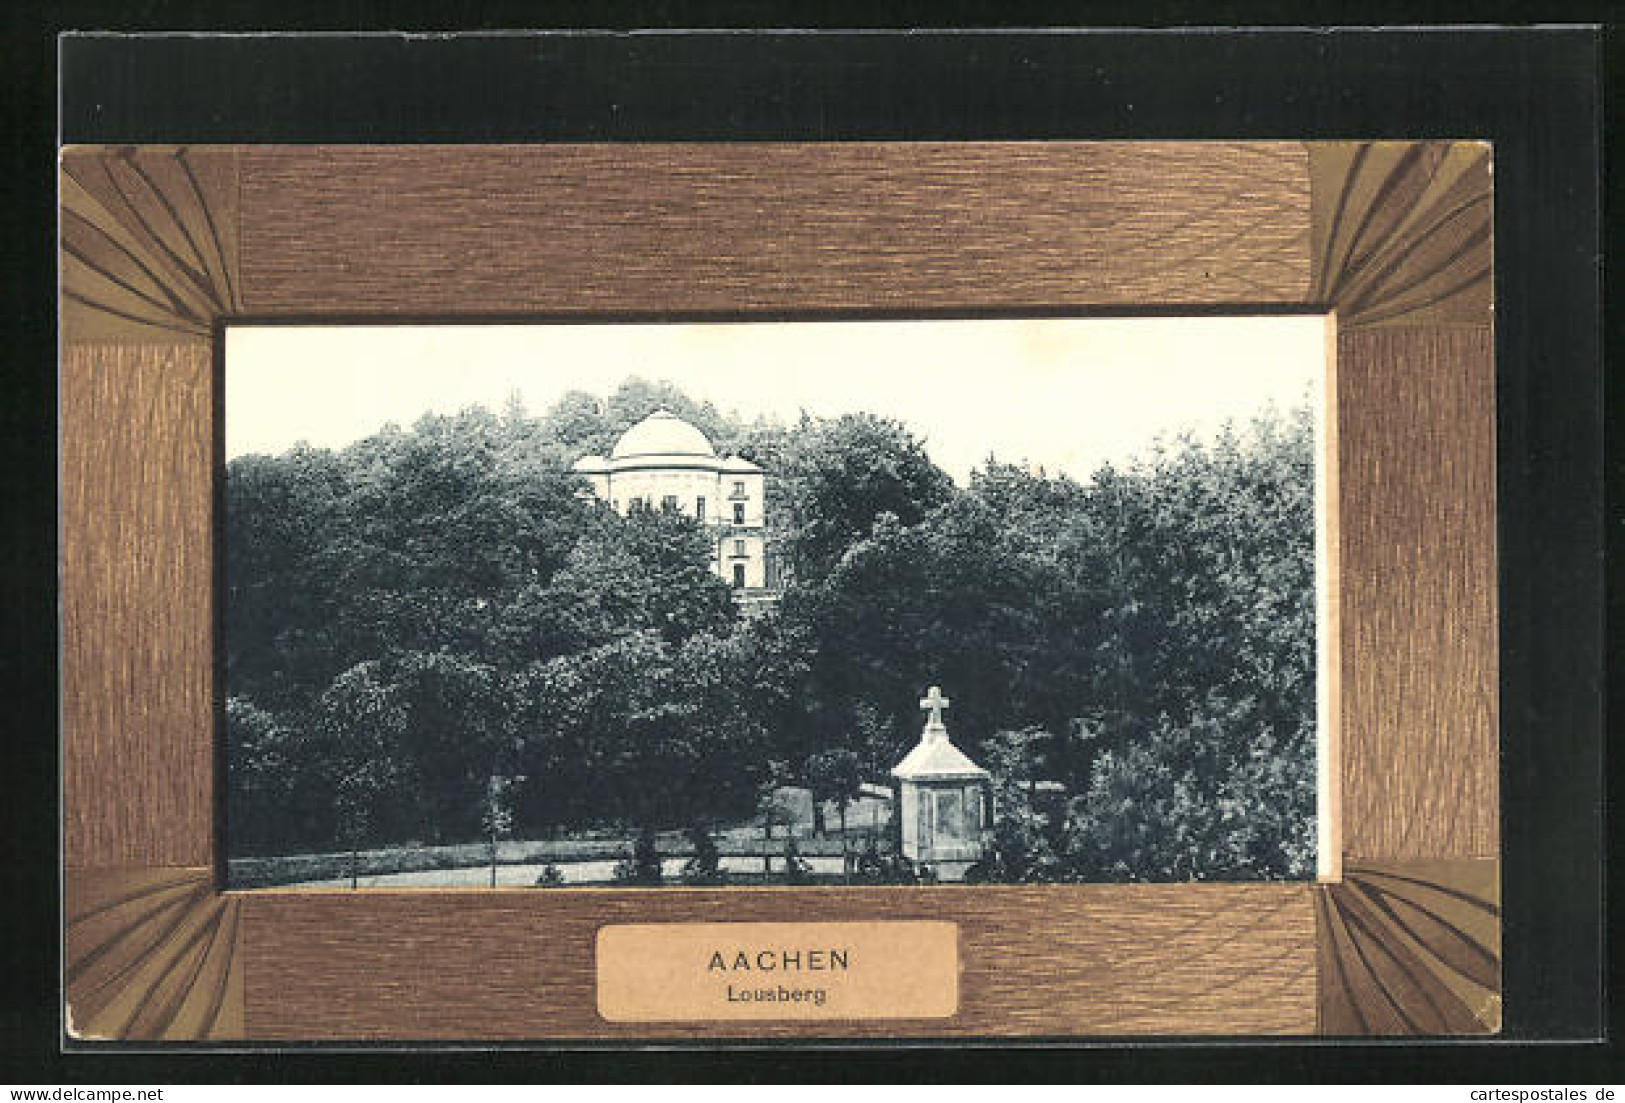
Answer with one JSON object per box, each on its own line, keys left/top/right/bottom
{"left": 60, "top": 140, "right": 1502, "bottom": 1043}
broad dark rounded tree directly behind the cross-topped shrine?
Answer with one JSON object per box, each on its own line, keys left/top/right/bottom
{"left": 782, "top": 494, "right": 1090, "bottom": 770}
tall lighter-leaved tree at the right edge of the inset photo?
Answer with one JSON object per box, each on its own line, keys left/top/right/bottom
{"left": 1069, "top": 409, "right": 1315, "bottom": 880}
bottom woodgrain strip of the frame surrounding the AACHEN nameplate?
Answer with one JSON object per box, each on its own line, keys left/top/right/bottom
{"left": 242, "top": 885, "right": 1316, "bottom": 1040}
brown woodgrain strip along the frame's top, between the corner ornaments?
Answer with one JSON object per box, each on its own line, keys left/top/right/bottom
{"left": 242, "top": 143, "right": 1310, "bottom": 314}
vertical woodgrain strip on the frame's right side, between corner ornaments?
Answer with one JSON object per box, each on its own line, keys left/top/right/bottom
{"left": 1337, "top": 327, "right": 1500, "bottom": 859}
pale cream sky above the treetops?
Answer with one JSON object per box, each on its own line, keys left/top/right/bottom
{"left": 226, "top": 315, "right": 1326, "bottom": 484}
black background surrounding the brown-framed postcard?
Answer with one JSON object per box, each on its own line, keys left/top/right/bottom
{"left": 0, "top": 3, "right": 1625, "bottom": 1087}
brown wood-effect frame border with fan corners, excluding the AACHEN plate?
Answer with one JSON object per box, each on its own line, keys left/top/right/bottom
{"left": 60, "top": 141, "right": 1500, "bottom": 1041}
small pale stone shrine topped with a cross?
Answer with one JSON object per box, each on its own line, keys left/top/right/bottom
{"left": 892, "top": 686, "right": 990, "bottom": 880}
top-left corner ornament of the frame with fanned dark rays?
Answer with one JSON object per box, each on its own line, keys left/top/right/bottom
{"left": 59, "top": 146, "right": 242, "bottom": 341}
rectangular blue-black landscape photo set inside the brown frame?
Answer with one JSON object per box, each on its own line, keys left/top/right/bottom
{"left": 219, "top": 315, "right": 1329, "bottom": 889}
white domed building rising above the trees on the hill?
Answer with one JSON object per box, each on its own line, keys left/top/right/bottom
{"left": 575, "top": 409, "right": 778, "bottom": 601}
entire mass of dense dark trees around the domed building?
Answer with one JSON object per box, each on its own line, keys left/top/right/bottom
{"left": 224, "top": 380, "right": 1315, "bottom": 880}
